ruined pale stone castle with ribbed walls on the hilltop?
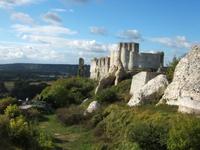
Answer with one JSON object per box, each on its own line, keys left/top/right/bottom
{"left": 90, "top": 43, "right": 164, "bottom": 80}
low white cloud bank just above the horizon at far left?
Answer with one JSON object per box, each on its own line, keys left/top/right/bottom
{"left": 0, "top": 42, "right": 63, "bottom": 63}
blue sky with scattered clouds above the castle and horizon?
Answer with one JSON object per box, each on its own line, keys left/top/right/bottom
{"left": 0, "top": 0, "right": 200, "bottom": 64}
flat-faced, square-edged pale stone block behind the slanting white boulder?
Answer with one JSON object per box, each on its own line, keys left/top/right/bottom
{"left": 130, "top": 71, "right": 157, "bottom": 95}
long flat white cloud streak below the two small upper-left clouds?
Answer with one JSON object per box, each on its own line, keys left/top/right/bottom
{"left": 12, "top": 24, "right": 77, "bottom": 36}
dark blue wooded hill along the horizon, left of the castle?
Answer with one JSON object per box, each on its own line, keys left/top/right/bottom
{"left": 0, "top": 63, "right": 90, "bottom": 81}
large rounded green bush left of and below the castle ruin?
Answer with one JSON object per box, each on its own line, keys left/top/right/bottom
{"left": 39, "top": 78, "right": 95, "bottom": 108}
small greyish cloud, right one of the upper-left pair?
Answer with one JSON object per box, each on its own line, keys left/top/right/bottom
{"left": 42, "top": 12, "right": 62, "bottom": 24}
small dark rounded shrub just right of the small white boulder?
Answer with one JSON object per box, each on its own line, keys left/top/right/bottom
{"left": 96, "top": 88, "right": 118, "bottom": 103}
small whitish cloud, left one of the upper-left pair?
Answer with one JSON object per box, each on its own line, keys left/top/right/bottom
{"left": 10, "top": 12, "right": 34, "bottom": 24}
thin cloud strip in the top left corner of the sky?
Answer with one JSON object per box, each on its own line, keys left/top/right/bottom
{"left": 0, "top": 0, "right": 36, "bottom": 8}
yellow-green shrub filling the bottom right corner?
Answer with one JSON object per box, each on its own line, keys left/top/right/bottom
{"left": 167, "top": 116, "right": 200, "bottom": 150}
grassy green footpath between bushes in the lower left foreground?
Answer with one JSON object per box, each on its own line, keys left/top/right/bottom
{"left": 39, "top": 115, "right": 95, "bottom": 150}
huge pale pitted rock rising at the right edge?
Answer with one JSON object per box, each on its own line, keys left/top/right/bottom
{"left": 160, "top": 46, "right": 200, "bottom": 113}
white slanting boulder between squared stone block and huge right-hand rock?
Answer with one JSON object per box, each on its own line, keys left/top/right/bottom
{"left": 128, "top": 74, "right": 168, "bottom": 106}
